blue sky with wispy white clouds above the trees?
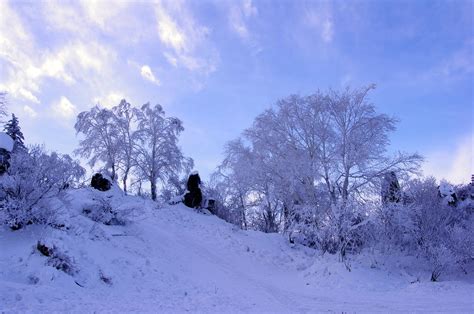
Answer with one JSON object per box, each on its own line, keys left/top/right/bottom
{"left": 0, "top": 0, "right": 474, "bottom": 183}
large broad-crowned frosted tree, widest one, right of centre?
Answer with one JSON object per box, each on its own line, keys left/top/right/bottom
{"left": 217, "top": 86, "right": 421, "bottom": 237}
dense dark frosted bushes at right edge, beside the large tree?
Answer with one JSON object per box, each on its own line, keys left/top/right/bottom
{"left": 377, "top": 178, "right": 474, "bottom": 281}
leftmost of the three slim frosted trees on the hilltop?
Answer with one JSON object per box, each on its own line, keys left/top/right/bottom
{"left": 74, "top": 106, "right": 121, "bottom": 180}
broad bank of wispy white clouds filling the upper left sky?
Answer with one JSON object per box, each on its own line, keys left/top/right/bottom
{"left": 0, "top": 0, "right": 219, "bottom": 116}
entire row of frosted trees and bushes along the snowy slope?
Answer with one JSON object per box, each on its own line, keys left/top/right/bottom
{"left": 0, "top": 85, "right": 474, "bottom": 280}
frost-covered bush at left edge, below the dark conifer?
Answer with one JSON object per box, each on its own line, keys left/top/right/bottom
{"left": 0, "top": 146, "right": 84, "bottom": 229}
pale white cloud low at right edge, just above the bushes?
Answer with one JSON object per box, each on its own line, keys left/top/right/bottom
{"left": 423, "top": 134, "right": 474, "bottom": 184}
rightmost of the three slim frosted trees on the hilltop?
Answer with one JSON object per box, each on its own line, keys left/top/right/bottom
{"left": 135, "top": 103, "right": 184, "bottom": 200}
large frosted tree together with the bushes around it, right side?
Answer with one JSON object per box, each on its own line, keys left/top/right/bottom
{"left": 213, "top": 86, "right": 474, "bottom": 280}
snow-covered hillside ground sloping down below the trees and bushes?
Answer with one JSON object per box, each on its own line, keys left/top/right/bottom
{"left": 0, "top": 189, "right": 474, "bottom": 313}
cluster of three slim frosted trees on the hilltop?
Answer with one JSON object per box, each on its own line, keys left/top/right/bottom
{"left": 75, "top": 99, "right": 192, "bottom": 200}
